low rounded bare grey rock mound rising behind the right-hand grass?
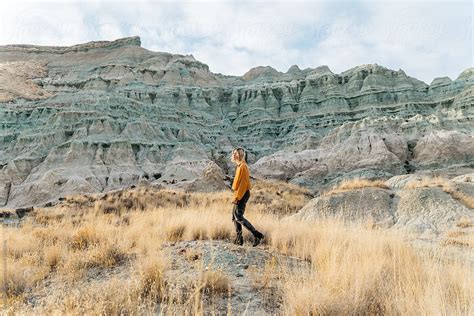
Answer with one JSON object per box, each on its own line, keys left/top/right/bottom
{"left": 292, "top": 181, "right": 474, "bottom": 235}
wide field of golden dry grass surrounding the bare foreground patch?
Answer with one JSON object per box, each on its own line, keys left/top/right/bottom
{"left": 0, "top": 183, "right": 474, "bottom": 315}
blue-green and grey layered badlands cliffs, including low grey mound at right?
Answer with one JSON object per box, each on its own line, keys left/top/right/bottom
{"left": 0, "top": 37, "right": 474, "bottom": 233}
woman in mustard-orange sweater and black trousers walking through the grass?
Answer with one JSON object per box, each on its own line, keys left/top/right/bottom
{"left": 231, "top": 147, "right": 264, "bottom": 247}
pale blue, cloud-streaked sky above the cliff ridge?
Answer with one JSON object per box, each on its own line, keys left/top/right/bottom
{"left": 0, "top": 0, "right": 474, "bottom": 84}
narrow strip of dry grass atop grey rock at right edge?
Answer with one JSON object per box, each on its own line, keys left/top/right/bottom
{"left": 405, "top": 176, "right": 474, "bottom": 209}
